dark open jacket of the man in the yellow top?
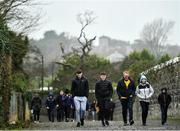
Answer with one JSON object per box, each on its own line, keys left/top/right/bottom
{"left": 117, "top": 78, "right": 136, "bottom": 97}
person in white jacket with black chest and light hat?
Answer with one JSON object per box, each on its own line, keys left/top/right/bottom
{"left": 136, "top": 75, "right": 154, "bottom": 126}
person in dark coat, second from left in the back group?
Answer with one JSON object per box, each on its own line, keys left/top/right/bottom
{"left": 46, "top": 93, "right": 56, "bottom": 122}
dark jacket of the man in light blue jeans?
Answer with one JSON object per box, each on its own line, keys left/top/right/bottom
{"left": 71, "top": 76, "right": 89, "bottom": 97}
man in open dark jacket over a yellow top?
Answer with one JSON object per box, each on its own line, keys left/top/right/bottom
{"left": 117, "top": 71, "right": 136, "bottom": 126}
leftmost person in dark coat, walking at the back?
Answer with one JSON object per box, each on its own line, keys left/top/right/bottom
{"left": 31, "top": 94, "right": 42, "bottom": 123}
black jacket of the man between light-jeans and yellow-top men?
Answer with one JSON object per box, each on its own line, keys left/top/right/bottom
{"left": 95, "top": 80, "right": 113, "bottom": 100}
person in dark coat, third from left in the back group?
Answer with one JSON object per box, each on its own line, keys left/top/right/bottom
{"left": 56, "top": 90, "right": 65, "bottom": 122}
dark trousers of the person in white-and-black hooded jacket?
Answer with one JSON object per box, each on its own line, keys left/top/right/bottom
{"left": 140, "top": 101, "right": 149, "bottom": 124}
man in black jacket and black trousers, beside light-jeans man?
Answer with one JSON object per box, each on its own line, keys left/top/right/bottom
{"left": 95, "top": 72, "right": 113, "bottom": 126}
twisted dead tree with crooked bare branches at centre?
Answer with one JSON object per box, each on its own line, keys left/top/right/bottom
{"left": 56, "top": 11, "right": 96, "bottom": 69}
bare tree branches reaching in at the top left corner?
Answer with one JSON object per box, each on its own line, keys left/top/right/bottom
{"left": 0, "top": 0, "right": 41, "bottom": 33}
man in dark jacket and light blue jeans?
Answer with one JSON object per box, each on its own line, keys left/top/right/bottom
{"left": 71, "top": 70, "right": 89, "bottom": 127}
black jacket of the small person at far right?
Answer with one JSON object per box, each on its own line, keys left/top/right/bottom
{"left": 158, "top": 92, "right": 171, "bottom": 106}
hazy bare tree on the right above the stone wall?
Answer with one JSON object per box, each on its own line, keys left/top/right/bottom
{"left": 141, "top": 19, "right": 174, "bottom": 58}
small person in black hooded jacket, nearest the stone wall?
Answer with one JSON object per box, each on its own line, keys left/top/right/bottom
{"left": 158, "top": 88, "right": 171, "bottom": 125}
